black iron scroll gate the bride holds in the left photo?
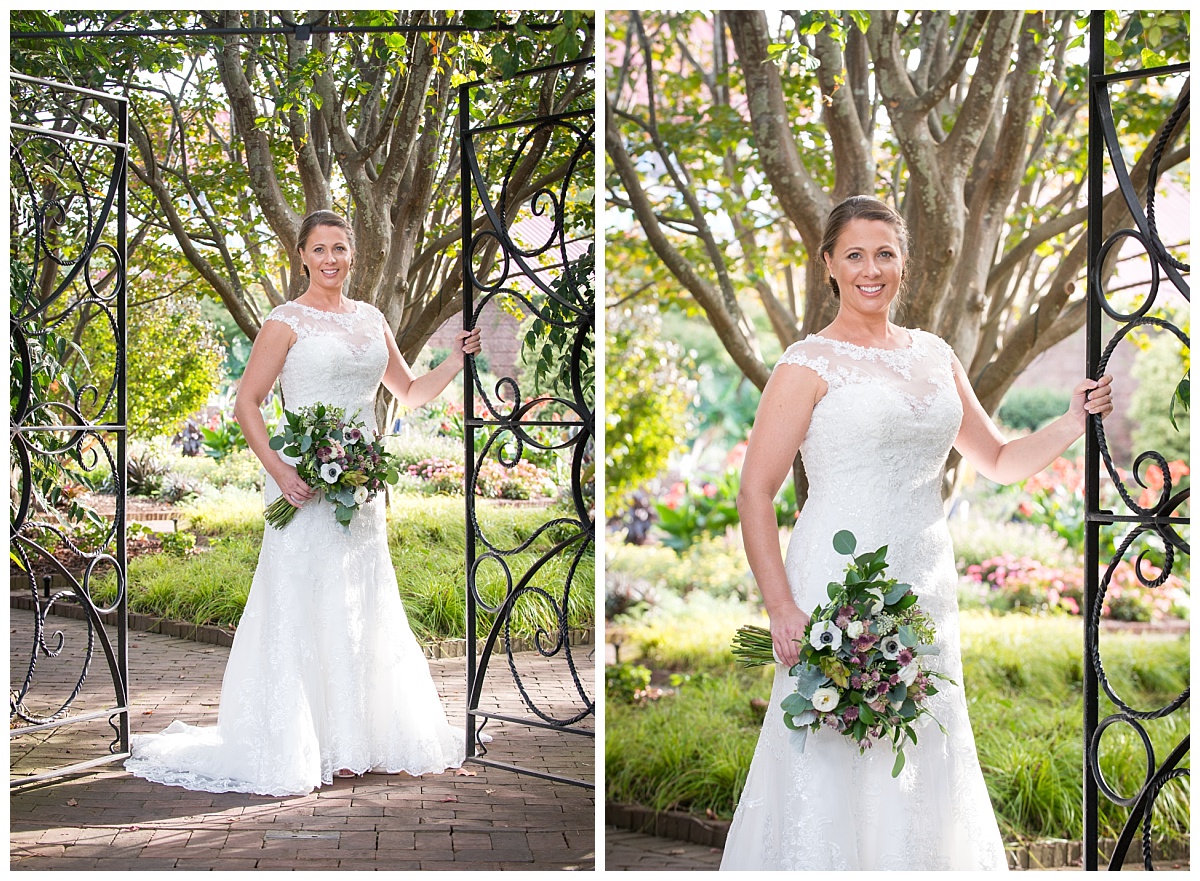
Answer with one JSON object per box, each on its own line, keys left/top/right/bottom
{"left": 460, "top": 58, "right": 595, "bottom": 787}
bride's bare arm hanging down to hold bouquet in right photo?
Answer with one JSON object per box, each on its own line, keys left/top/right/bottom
{"left": 738, "top": 364, "right": 828, "bottom": 666}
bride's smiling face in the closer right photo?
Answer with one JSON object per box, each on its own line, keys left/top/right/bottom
{"left": 824, "top": 218, "right": 904, "bottom": 314}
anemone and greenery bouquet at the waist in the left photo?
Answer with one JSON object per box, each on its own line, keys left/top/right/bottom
{"left": 265, "top": 403, "right": 400, "bottom": 529}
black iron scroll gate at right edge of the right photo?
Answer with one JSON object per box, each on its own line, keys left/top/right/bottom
{"left": 1084, "top": 12, "right": 1190, "bottom": 870}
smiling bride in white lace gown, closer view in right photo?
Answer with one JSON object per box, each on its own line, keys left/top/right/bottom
{"left": 721, "top": 196, "right": 1112, "bottom": 870}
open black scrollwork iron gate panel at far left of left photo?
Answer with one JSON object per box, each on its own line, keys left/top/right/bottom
{"left": 8, "top": 73, "right": 130, "bottom": 786}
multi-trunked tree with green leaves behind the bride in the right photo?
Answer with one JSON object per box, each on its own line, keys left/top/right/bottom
{"left": 605, "top": 11, "right": 1189, "bottom": 496}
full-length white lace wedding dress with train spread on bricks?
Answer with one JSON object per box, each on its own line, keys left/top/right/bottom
{"left": 125, "top": 302, "right": 466, "bottom": 796}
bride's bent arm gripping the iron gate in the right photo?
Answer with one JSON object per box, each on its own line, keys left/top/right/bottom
{"left": 953, "top": 356, "right": 1112, "bottom": 484}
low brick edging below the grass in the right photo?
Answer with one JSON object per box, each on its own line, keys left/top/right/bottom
{"left": 604, "top": 802, "right": 1189, "bottom": 869}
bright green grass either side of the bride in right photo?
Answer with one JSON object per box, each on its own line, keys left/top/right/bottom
{"left": 605, "top": 604, "right": 1189, "bottom": 841}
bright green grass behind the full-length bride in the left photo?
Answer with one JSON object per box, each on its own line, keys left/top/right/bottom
{"left": 95, "top": 489, "right": 595, "bottom": 642}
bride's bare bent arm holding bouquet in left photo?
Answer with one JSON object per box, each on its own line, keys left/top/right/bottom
{"left": 233, "top": 320, "right": 313, "bottom": 507}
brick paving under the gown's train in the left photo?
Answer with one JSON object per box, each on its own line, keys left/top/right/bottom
{"left": 10, "top": 610, "right": 595, "bottom": 870}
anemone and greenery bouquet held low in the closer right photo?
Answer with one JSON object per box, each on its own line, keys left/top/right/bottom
{"left": 733, "top": 529, "right": 954, "bottom": 777}
